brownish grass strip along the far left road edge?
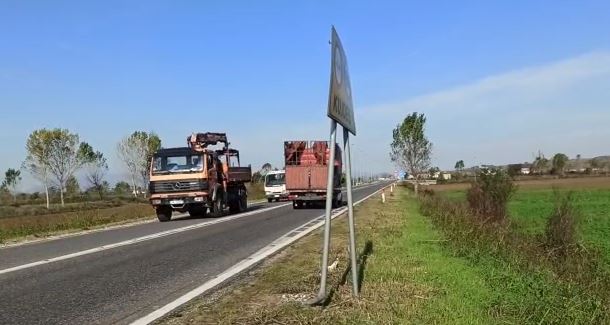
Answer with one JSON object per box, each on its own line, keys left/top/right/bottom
{"left": 0, "top": 203, "right": 154, "bottom": 243}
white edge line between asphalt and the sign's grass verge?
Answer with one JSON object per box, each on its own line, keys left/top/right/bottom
{"left": 131, "top": 186, "right": 387, "bottom": 325}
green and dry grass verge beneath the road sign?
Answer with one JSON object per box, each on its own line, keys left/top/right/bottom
{"left": 161, "top": 187, "right": 592, "bottom": 324}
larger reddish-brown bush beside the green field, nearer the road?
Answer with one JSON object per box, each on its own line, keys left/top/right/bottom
{"left": 466, "top": 170, "right": 517, "bottom": 222}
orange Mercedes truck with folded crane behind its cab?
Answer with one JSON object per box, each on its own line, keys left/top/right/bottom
{"left": 149, "top": 132, "right": 252, "bottom": 222}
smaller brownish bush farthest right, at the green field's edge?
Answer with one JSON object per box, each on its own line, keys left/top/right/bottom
{"left": 545, "top": 191, "right": 579, "bottom": 255}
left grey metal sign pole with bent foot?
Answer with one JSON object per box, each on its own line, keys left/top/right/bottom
{"left": 310, "top": 120, "right": 337, "bottom": 305}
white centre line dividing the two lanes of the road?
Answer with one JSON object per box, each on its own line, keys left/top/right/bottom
{"left": 0, "top": 203, "right": 292, "bottom": 275}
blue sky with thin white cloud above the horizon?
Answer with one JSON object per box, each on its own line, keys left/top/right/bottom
{"left": 0, "top": 0, "right": 610, "bottom": 187}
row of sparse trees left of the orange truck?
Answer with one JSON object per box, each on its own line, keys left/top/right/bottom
{"left": 0, "top": 128, "right": 161, "bottom": 208}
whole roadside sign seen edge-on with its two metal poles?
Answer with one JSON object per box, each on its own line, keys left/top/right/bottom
{"left": 309, "top": 26, "right": 358, "bottom": 305}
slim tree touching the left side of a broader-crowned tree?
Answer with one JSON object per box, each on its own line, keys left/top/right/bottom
{"left": 23, "top": 129, "right": 51, "bottom": 209}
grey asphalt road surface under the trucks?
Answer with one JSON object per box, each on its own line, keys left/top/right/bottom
{"left": 0, "top": 184, "right": 384, "bottom": 324}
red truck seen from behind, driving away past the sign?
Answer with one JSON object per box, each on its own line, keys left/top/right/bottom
{"left": 284, "top": 141, "right": 343, "bottom": 209}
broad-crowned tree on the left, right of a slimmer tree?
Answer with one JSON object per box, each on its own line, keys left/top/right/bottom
{"left": 41, "top": 129, "right": 87, "bottom": 206}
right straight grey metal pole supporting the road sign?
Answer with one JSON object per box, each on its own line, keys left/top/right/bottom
{"left": 343, "top": 127, "right": 359, "bottom": 297}
